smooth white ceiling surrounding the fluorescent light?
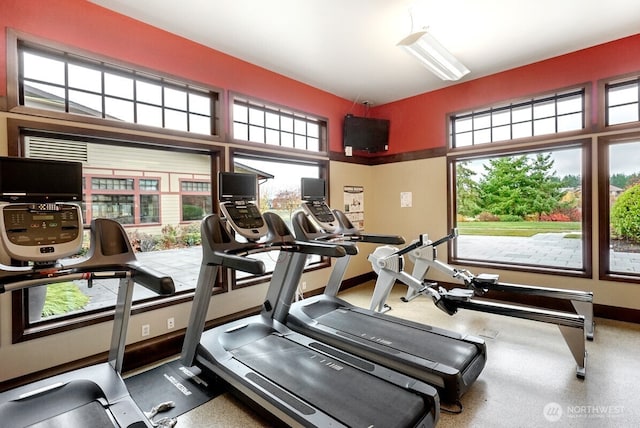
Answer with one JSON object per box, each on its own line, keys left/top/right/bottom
{"left": 90, "top": 0, "right": 640, "bottom": 105}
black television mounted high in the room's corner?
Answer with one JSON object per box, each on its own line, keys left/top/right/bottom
{"left": 342, "top": 114, "right": 389, "bottom": 153}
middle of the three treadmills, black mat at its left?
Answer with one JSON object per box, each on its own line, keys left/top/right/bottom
{"left": 181, "top": 172, "right": 439, "bottom": 427}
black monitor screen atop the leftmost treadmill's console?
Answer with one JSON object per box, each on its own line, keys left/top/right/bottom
{"left": 0, "top": 157, "right": 82, "bottom": 203}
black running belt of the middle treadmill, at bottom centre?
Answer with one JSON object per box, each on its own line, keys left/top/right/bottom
{"left": 233, "top": 335, "right": 431, "bottom": 427}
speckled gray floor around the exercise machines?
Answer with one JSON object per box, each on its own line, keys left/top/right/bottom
{"left": 172, "top": 283, "right": 640, "bottom": 428}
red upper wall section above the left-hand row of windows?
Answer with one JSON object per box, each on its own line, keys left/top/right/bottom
{"left": 0, "top": 0, "right": 359, "bottom": 151}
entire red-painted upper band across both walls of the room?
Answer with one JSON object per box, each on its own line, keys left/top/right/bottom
{"left": 0, "top": 0, "right": 640, "bottom": 154}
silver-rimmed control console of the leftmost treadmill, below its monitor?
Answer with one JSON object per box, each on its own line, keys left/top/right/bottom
{"left": 0, "top": 203, "right": 83, "bottom": 262}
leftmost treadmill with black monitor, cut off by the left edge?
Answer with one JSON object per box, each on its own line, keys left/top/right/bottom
{"left": 0, "top": 157, "right": 174, "bottom": 428}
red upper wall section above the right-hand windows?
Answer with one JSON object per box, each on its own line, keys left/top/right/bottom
{"left": 371, "top": 34, "right": 640, "bottom": 154}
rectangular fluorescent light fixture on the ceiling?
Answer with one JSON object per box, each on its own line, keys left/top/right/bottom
{"left": 398, "top": 31, "right": 469, "bottom": 80}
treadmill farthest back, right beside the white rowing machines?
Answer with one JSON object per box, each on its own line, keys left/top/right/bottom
{"left": 276, "top": 178, "right": 486, "bottom": 408}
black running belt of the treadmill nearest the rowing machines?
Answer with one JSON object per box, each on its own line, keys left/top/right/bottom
{"left": 316, "top": 308, "right": 478, "bottom": 371}
